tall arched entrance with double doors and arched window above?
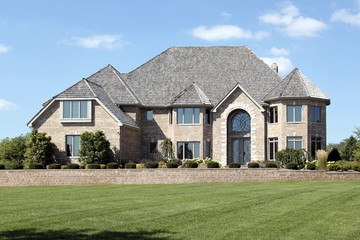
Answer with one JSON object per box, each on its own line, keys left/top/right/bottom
{"left": 227, "top": 110, "right": 251, "bottom": 164}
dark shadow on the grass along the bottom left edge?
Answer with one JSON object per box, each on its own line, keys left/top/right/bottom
{"left": 0, "top": 229, "right": 173, "bottom": 240}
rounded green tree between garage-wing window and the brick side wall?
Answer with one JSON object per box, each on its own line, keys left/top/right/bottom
{"left": 79, "top": 131, "right": 111, "bottom": 164}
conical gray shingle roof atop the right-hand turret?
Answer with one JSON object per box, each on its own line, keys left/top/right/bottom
{"left": 264, "top": 68, "right": 330, "bottom": 104}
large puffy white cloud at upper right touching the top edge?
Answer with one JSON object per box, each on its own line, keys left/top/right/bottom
{"left": 259, "top": 2, "right": 327, "bottom": 37}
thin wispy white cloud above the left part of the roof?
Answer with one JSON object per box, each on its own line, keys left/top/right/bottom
{"left": 63, "top": 35, "right": 129, "bottom": 50}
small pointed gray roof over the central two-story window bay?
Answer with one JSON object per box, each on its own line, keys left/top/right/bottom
{"left": 171, "top": 83, "right": 212, "bottom": 106}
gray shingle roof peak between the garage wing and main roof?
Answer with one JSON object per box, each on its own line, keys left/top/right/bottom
{"left": 87, "top": 64, "right": 141, "bottom": 105}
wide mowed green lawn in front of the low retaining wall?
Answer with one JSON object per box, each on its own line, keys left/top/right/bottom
{"left": 0, "top": 181, "right": 360, "bottom": 240}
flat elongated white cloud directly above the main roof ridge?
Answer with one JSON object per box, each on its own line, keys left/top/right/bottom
{"left": 192, "top": 25, "right": 269, "bottom": 41}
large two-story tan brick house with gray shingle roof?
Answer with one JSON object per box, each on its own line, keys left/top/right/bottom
{"left": 28, "top": 46, "right": 330, "bottom": 165}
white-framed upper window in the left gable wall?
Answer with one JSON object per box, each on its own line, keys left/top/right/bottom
{"left": 63, "top": 101, "right": 89, "bottom": 119}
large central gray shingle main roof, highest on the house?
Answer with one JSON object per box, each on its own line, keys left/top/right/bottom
{"left": 121, "top": 46, "right": 282, "bottom": 107}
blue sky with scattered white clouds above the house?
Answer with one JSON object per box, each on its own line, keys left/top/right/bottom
{"left": 0, "top": 0, "right": 360, "bottom": 143}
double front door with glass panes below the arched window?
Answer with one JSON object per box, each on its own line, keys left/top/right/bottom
{"left": 230, "top": 138, "right": 250, "bottom": 165}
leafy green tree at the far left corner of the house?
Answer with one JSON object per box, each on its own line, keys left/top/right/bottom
{"left": 24, "top": 129, "right": 54, "bottom": 166}
